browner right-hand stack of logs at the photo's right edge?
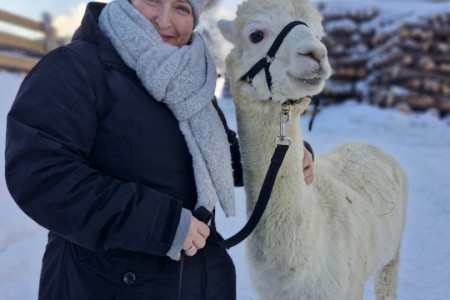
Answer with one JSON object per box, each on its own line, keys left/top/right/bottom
{"left": 368, "top": 12, "right": 450, "bottom": 116}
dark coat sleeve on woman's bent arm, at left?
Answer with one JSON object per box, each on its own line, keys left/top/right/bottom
{"left": 5, "top": 48, "right": 182, "bottom": 256}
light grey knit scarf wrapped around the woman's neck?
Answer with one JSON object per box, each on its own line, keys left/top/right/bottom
{"left": 99, "top": 0, "right": 235, "bottom": 216}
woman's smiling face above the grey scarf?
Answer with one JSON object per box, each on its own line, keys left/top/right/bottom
{"left": 130, "top": 0, "right": 194, "bottom": 47}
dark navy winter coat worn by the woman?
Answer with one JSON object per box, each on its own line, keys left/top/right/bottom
{"left": 5, "top": 3, "right": 239, "bottom": 300}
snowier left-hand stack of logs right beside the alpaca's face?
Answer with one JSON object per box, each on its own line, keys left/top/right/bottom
{"left": 318, "top": 3, "right": 379, "bottom": 104}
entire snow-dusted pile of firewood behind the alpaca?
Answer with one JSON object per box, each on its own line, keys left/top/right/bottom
{"left": 319, "top": 4, "right": 450, "bottom": 116}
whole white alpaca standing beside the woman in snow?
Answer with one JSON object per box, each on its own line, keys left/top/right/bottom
{"left": 219, "top": 0, "right": 408, "bottom": 300}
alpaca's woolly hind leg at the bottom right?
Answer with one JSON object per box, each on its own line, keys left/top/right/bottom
{"left": 375, "top": 253, "right": 399, "bottom": 300}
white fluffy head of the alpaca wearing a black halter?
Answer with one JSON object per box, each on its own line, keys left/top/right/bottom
{"left": 219, "top": 0, "right": 331, "bottom": 109}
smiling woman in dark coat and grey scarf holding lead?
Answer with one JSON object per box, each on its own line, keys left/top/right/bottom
{"left": 6, "top": 0, "right": 312, "bottom": 300}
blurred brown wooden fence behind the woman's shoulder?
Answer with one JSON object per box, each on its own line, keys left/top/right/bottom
{"left": 0, "top": 9, "right": 56, "bottom": 72}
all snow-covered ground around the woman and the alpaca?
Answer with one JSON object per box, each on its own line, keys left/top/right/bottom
{"left": 0, "top": 71, "right": 450, "bottom": 300}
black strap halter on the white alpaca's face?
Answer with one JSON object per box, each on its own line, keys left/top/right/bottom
{"left": 241, "top": 21, "right": 308, "bottom": 91}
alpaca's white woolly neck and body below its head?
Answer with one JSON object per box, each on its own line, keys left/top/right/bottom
{"left": 237, "top": 104, "right": 407, "bottom": 300}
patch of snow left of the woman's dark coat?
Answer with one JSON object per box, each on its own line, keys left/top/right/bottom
{"left": 0, "top": 71, "right": 46, "bottom": 300}
